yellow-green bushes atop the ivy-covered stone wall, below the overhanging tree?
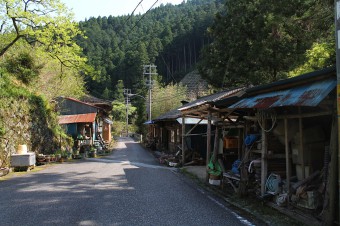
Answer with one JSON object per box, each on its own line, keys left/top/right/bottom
{"left": 0, "top": 40, "right": 85, "bottom": 101}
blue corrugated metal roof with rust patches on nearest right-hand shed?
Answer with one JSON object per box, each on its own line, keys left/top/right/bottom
{"left": 228, "top": 78, "right": 336, "bottom": 109}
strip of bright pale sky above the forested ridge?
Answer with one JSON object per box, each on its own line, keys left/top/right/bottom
{"left": 61, "top": 0, "right": 183, "bottom": 21}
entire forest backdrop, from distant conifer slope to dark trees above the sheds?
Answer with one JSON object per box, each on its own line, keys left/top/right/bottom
{"left": 77, "top": 0, "right": 335, "bottom": 97}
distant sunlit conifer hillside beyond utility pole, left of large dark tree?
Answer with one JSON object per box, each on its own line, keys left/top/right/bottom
{"left": 78, "top": 0, "right": 223, "bottom": 96}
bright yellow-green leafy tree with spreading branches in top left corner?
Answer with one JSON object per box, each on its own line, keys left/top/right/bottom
{"left": 0, "top": 0, "right": 88, "bottom": 69}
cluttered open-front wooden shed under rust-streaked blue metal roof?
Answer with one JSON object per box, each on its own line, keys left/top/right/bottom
{"left": 215, "top": 68, "right": 339, "bottom": 222}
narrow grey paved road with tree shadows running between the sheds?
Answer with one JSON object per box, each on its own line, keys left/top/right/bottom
{"left": 0, "top": 138, "right": 252, "bottom": 226}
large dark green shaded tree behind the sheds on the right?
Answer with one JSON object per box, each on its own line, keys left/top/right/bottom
{"left": 200, "top": 0, "right": 332, "bottom": 88}
